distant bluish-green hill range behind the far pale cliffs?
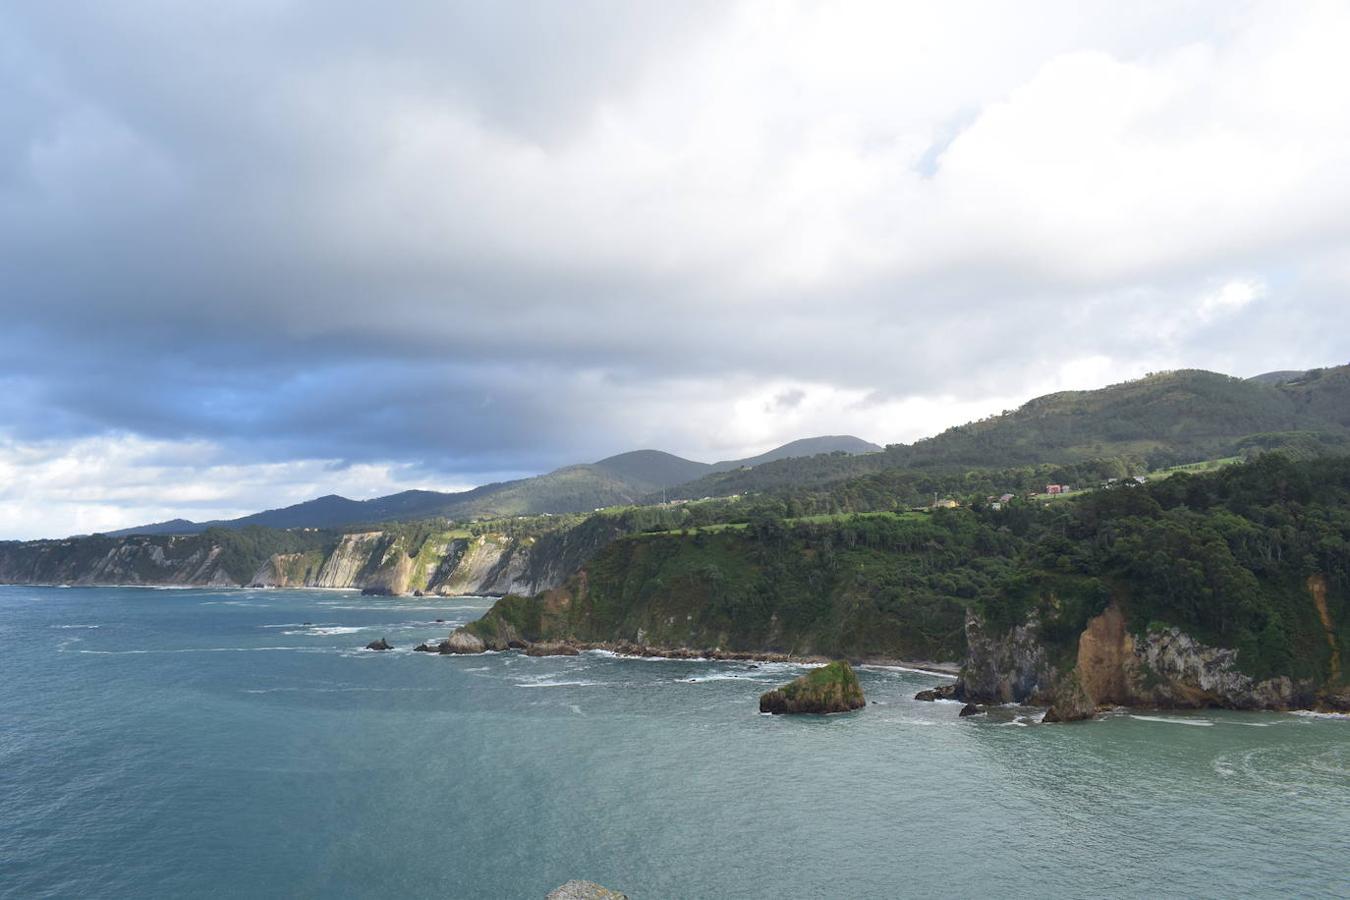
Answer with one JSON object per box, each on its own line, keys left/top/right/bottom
{"left": 111, "top": 436, "right": 878, "bottom": 537}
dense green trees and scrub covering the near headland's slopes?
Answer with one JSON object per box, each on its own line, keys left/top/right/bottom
{"left": 471, "top": 455, "right": 1350, "bottom": 683}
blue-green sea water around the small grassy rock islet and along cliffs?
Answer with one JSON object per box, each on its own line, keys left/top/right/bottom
{"left": 0, "top": 587, "right": 1350, "bottom": 900}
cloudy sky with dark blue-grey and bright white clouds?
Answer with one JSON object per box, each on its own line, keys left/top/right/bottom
{"left": 0, "top": 0, "right": 1350, "bottom": 538}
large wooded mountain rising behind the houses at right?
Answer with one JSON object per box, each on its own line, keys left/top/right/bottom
{"left": 674, "top": 366, "right": 1350, "bottom": 498}
